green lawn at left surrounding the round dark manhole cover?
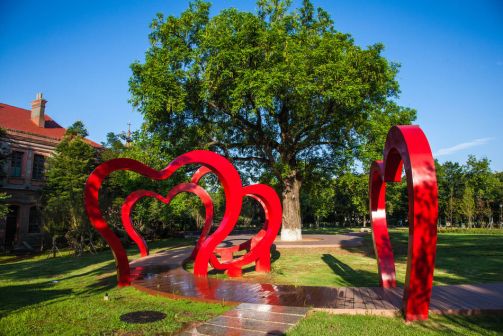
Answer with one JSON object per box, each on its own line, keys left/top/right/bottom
{"left": 0, "top": 239, "right": 230, "bottom": 335}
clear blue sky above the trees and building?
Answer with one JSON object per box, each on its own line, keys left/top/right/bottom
{"left": 0, "top": 0, "right": 503, "bottom": 170}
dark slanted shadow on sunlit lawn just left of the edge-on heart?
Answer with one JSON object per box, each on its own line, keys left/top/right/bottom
{"left": 321, "top": 254, "right": 379, "bottom": 287}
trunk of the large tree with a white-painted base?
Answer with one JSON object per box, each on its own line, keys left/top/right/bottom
{"left": 281, "top": 173, "right": 302, "bottom": 241}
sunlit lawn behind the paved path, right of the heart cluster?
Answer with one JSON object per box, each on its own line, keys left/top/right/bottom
{"left": 209, "top": 229, "right": 503, "bottom": 287}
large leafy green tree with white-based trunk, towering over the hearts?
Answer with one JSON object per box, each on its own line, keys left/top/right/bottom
{"left": 130, "top": 0, "right": 415, "bottom": 240}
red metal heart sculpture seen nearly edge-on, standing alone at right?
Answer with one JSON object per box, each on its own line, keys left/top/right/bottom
{"left": 369, "top": 126, "right": 438, "bottom": 321}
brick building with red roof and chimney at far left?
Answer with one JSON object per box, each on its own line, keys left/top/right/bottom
{"left": 0, "top": 93, "right": 101, "bottom": 250}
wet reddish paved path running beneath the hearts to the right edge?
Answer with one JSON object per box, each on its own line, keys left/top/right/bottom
{"left": 131, "top": 243, "right": 503, "bottom": 315}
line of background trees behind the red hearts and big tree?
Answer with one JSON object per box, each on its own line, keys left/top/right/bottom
{"left": 42, "top": 122, "right": 503, "bottom": 253}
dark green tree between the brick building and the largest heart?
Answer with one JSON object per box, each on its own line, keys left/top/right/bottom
{"left": 42, "top": 122, "right": 98, "bottom": 254}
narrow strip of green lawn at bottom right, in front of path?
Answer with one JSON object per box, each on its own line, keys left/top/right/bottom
{"left": 287, "top": 312, "right": 503, "bottom": 336}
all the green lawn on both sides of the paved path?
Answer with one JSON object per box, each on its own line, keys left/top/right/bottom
{"left": 0, "top": 229, "right": 503, "bottom": 336}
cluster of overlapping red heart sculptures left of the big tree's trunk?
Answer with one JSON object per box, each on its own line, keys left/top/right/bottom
{"left": 85, "top": 150, "right": 282, "bottom": 286}
